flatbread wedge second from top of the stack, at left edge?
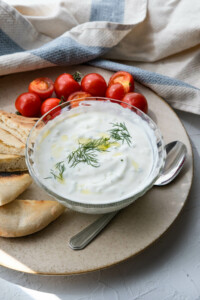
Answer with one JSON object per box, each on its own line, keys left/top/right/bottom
{"left": 0, "top": 128, "right": 25, "bottom": 155}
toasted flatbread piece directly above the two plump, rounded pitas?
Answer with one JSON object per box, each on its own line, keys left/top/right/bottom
{"left": 0, "top": 154, "right": 27, "bottom": 172}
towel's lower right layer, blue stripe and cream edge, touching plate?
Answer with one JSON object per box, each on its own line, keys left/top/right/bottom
{"left": 88, "top": 59, "right": 200, "bottom": 114}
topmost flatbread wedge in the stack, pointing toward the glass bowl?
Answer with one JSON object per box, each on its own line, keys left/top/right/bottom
{"left": 0, "top": 110, "right": 38, "bottom": 143}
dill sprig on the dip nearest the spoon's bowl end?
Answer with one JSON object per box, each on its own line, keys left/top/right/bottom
{"left": 109, "top": 123, "right": 131, "bottom": 146}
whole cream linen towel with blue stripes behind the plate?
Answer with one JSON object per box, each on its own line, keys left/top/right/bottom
{"left": 0, "top": 0, "right": 200, "bottom": 114}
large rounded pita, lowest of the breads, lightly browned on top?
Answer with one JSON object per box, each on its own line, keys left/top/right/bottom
{"left": 0, "top": 200, "right": 65, "bottom": 237}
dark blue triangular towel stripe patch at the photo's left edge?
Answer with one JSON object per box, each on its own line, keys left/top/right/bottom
{"left": 0, "top": 29, "right": 24, "bottom": 55}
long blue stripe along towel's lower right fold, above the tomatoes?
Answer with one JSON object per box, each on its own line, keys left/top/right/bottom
{"left": 88, "top": 59, "right": 199, "bottom": 90}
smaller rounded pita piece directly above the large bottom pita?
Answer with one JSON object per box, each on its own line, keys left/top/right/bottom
{"left": 0, "top": 172, "right": 32, "bottom": 206}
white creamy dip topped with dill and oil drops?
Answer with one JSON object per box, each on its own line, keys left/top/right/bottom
{"left": 33, "top": 101, "right": 157, "bottom": 203}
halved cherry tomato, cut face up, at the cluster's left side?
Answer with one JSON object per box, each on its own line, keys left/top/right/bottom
{"left": 28, "top": 77, "right": 54, "bottom": 100}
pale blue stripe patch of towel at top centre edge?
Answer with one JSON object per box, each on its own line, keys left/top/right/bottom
{"left": 90, "top": 0, "right": 124, "bottom": 23}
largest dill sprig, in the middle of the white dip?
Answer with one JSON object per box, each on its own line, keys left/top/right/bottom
{"left": 67, "top": 138, "right": 109, "bottom": 168}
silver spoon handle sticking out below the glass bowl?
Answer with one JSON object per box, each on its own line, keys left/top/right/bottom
{"left": 69, "top": 211, "right": 119, "bottom": 250}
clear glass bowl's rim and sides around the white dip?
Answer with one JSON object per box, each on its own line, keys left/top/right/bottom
{"left": 26, "top": 97, "right": 166, "bottom": 214}
